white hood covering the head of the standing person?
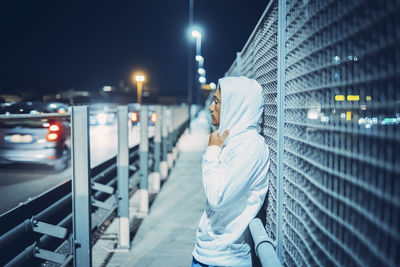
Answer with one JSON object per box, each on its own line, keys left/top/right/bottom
{"left": 218, "top": 76, "right": 264, "bottom": 138}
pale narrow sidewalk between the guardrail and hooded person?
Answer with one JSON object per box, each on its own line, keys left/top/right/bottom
{"left": 107, "top": 112, "right": 209, "bottom": 267}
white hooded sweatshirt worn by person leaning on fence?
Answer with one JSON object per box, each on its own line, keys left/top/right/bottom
{"left": 193, "top": 77, "right": 269, "bottom": 266}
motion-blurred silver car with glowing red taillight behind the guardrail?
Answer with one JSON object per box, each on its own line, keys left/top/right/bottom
{"left": 0, "top": 102, "right": 71, "bottom": 171}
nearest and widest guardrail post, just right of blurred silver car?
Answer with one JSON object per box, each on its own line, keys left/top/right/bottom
{"left": 71, "top": 106, "right": 92, "bottom": 267}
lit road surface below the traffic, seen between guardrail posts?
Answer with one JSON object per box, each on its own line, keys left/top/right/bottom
{"left": 0, "top": 123, "right": 154, "bottom": 214}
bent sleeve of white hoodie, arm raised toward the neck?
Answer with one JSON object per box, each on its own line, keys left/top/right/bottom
{"left": 202, "top": 143, "right": 262, "bottom": 210}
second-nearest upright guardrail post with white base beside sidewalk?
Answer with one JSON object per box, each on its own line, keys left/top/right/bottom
{"left": 117, "top": 106, "right": 130, "bottom": 249}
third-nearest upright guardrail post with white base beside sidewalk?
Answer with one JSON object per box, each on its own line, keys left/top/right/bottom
{"left": 139, "top": 105, "right": 149, "bottom": 214}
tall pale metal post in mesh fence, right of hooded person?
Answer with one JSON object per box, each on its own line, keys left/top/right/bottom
{"left": 276, "top": 0, "right": 286, "bottom": 262}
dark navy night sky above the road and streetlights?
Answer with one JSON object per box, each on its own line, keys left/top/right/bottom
{"left": 0, "top": 0, "right": 268, "bottom": 95}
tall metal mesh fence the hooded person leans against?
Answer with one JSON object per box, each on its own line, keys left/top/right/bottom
{"left": 226, "top": 0, "right": 400, "bottom": 266}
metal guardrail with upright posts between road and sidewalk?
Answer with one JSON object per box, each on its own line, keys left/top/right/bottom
{"left": 0, "top": 103, "right": 188, "bottom": 266}
